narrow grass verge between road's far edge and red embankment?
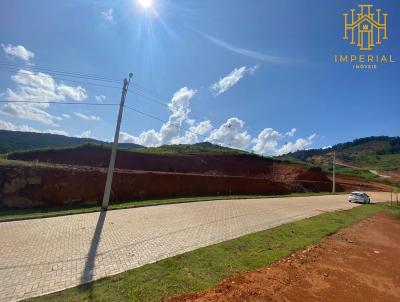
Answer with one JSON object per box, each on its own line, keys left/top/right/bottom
{"left": 0, "top": 193, "right": 344, "bottom": 222}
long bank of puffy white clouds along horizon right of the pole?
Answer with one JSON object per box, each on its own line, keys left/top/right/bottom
{"left": 120, "top": 87, "right": 315, "bottom": 155}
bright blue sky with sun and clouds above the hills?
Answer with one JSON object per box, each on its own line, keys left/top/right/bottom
{"left": 0, "top": 0, "right": 400, "bottom": 155}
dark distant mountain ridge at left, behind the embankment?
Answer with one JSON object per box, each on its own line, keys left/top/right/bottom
{"left": 0, "top": 130, "right": 144, "bottom": 154}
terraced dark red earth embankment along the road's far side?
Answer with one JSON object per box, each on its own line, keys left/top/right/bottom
{"left": 0, "top": 146, "right": 387, "bottom": 208}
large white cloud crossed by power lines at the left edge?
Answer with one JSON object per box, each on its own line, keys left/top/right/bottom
{"left": 0, "top": 69, "right": 87, "bottom": 126}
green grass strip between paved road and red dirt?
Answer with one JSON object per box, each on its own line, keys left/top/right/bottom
{"left": 30, "top": 204, "right": 400, "bottom": 302}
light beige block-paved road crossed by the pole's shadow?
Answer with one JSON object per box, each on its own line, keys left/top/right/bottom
{"left": 0, "top": 193, "right": 390, "bottom": 301}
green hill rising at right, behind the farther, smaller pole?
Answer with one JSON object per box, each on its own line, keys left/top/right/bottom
{"left": 280, "top": 136, "right": 400, "bottom": 183}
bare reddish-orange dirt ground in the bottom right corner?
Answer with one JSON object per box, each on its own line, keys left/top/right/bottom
{"left": 171, "top": 214, "right": 400, "bottom": 302}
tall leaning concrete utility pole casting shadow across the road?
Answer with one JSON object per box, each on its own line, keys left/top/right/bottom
{"left": 101, "top": 73, "right": 132, "bottom": 211}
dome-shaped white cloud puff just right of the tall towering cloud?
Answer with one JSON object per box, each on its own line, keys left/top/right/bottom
{"left": 207, "top": 117, "right": 251, "bottom": 149}
